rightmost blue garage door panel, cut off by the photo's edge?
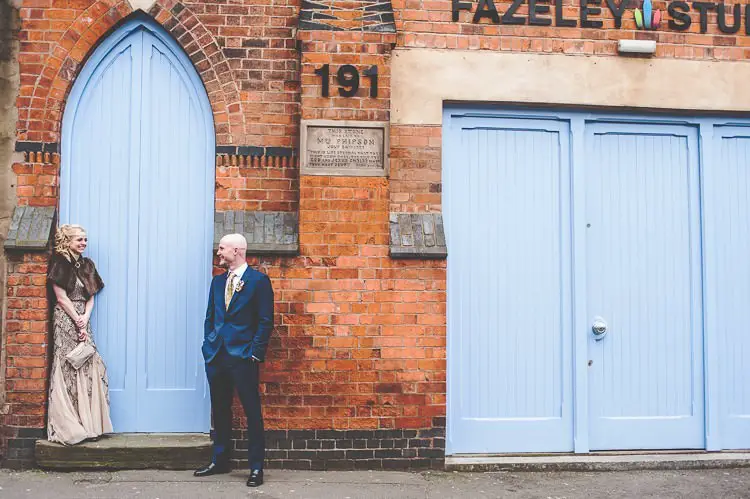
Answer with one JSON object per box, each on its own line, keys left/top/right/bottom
{"left": 704, "top": 125, "right": 750, "bottom": 449}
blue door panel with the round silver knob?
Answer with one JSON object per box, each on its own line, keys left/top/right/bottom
{"left": 581, "top": 123, "right": 705, "bottom": 450}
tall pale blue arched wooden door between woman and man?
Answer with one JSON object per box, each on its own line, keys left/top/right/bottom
{"left": 60, "top": 18, "right": 215, "bottom": 432}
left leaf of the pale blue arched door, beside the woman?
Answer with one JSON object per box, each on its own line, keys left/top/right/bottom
{"left": 60, "top": 23, "right": 142, "bottom": 431}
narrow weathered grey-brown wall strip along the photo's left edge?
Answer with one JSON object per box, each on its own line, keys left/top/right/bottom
{"left": 0, "top": 0, "right": 21, "bottom": 422}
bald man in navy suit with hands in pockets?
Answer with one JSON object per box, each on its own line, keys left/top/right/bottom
{"left": 194, "top": 234, "right": 273, "bottom": 487}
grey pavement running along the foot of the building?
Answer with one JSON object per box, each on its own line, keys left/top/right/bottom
{"left": 0, "top": 468, "right": 750, "bottom": 499}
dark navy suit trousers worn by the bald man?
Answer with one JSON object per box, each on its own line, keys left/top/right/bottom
{"left": 206, "top": 345, "right": 266, "bottom": 470}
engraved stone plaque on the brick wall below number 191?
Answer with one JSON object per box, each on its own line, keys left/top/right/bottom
{"left": 301, "top": 120, "right": 388, "bottom": 177}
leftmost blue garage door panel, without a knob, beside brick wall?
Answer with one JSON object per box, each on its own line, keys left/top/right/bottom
{"left": 443, "top": 111, "right": 573, "bottom": 454}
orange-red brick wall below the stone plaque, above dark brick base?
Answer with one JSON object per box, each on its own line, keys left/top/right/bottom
{"left": 250, "top": 176, "right": 445, "bottom": 429}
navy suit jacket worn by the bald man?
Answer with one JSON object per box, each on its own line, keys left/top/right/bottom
{"left": 202, "top": 267, "right": 273, "bottom": 363}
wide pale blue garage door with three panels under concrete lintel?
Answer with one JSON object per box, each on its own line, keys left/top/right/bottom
{"left": 443, "top": 109, "right": 750, "bottom": 454}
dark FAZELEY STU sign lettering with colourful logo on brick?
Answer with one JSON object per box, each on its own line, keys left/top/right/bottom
{"left": 451, "top": 0, "right": 750, "bottom": 35}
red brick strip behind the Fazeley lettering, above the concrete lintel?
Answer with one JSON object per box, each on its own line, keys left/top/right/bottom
{"left": 393, "top": 0, "right": 750, "bottom": 60}
